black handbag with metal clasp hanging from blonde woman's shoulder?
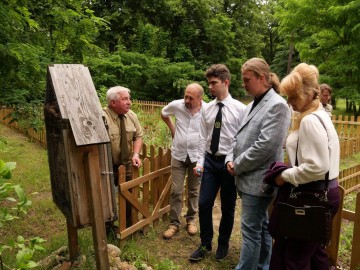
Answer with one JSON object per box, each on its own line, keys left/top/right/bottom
{"left": 269, "top": 114, "right": 332, "bottom": 245}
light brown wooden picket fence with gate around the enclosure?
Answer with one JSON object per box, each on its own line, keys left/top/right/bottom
{"left": 0, "top": 105, "right": 360, "bottom": 270}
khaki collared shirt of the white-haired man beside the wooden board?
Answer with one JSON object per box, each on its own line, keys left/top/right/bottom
{"left": 103, "top": 107, "right": 143, "bottom": 165}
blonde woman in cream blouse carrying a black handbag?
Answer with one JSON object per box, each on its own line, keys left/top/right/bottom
{"left": 269, "top": 63, "right": 340, "bottom": 270}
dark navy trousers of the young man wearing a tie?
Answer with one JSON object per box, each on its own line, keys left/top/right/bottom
{"left": 199, "top": 155, "right": 237, "bottom": 247}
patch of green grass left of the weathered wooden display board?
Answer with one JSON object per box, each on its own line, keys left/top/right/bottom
{"left": 0, "top": 129, "right": 67, "bottom": 265}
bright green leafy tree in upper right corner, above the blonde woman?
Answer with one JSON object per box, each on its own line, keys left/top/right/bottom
{"left": 276, "top": 0, "right": 360, "bottom": 114}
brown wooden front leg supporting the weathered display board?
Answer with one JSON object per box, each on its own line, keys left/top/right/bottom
{"left": 84, "top": 147, "right": 110, "bottom": 270}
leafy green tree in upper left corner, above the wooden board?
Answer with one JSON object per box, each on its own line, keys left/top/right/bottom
{"left": 0, "top": 0, "right": 105, "bottom": 104}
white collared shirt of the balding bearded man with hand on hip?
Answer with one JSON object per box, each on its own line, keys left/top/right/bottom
{"left": 161, "top": 99, "right": 206, "bottom": 162}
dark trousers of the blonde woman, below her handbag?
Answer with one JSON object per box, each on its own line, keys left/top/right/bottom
{"left": 270, "top": 187, "right": 340, "bottom": 270}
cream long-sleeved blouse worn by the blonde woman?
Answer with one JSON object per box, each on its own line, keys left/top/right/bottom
{"left": 281, "top": 108, "right": 340, "bottom": 186}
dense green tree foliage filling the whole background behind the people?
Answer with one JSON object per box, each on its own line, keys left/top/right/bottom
{"left": 0, "top": 0, "right": 360, "bottom": 109}
